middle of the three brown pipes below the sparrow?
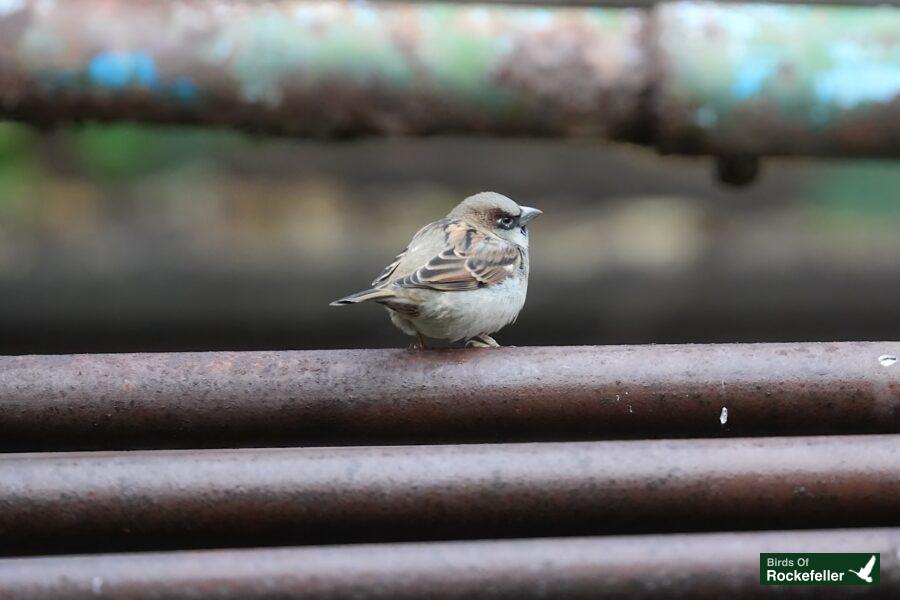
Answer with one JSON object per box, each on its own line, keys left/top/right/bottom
{"left": 0, "top": 435, "right": 900, "bottom": 553}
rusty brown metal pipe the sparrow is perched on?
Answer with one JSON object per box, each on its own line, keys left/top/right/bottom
{"left": 0, "top": 342, "right": 900, "bottom": 451}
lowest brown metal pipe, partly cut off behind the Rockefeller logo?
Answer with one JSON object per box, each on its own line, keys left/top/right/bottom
{"left": 0, "top": 529, "right": 900, "bottom": 600}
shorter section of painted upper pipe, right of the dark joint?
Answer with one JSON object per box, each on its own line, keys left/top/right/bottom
{"left": 657, "top": 2, "right": 900, "bottom": 156}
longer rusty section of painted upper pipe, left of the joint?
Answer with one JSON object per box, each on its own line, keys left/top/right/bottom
{"left": 0, "top": 0, "right": 648, "bottom": 137}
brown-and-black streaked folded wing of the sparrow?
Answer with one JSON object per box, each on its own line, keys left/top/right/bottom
{"left": 395, "top": 221, "right": 522, "bottom": 292}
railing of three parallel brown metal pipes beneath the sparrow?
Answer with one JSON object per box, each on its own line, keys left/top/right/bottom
{"left": 0, "top": 342, "right": 900, "bottom": 599}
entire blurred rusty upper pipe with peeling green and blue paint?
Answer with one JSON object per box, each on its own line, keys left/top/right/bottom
{"left": 0, "top": 0, "right": 900, "bottom": 156}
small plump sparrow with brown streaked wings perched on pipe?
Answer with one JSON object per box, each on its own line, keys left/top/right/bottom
{"left": 331, "top": 192, "right": 543, "bottom": 349}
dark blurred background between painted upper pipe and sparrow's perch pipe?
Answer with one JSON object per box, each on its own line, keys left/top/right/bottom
{"left": 0, "top": 123, "right": 900, "bottom": 354}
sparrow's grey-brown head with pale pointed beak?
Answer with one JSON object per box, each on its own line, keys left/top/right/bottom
{"left": 447, "top": 192, "right": 541, "bottom": 248}
